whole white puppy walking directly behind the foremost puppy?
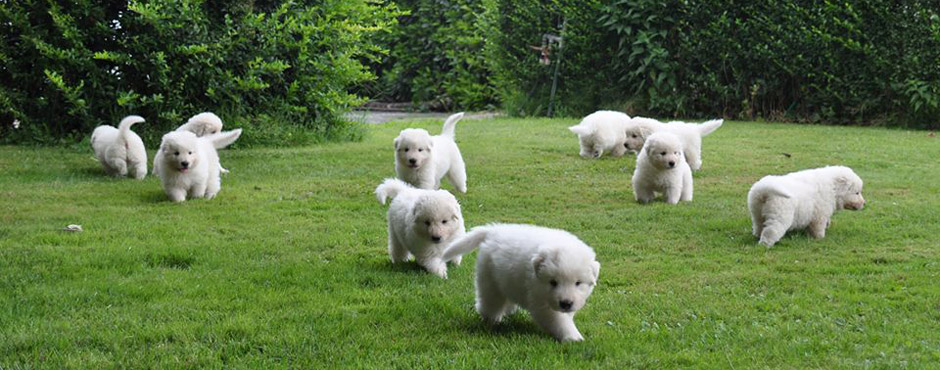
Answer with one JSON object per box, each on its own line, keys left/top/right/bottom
{"left": 375, "top": 179, "right": 465, "bottom": 279}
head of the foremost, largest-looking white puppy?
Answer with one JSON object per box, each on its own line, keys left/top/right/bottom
{"left": 531, "top": 244, "right": 601, "bottom": 312}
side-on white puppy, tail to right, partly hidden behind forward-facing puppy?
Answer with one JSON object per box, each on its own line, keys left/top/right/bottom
{"left": 625, "top": 117, "right": 724, "bottom": 171}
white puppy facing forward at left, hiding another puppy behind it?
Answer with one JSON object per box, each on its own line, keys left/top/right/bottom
{"left": 153, "top": 129, "right": 242, "bottom": 202}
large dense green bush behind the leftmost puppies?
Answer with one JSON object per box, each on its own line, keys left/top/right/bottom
{"left": 0, "top": 0, "right": 396, "bottom": 145}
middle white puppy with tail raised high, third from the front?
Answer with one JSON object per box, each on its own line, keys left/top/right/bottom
{"left": 395, "top": 112, "right": 467, "bottom": 193}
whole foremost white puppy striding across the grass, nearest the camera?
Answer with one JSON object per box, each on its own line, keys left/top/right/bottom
{"left": 444, "top": 224, "right": 601, "bottom": 342}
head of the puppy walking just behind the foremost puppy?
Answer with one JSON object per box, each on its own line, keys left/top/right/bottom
{"left": 412, "top": 190, "right": 463, "bottom": 246}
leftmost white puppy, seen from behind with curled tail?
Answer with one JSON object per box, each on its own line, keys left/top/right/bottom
{"left": 91, "top": 116, "right": 147, "bottom": 180}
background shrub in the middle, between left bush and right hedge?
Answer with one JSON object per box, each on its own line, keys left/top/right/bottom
{"left": 366, "top": 0, "right": 496, "bottom": 110}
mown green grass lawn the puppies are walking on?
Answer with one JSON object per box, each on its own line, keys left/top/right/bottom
{"left": 0, "top": 119, "right": 940, "bottom": 368}
